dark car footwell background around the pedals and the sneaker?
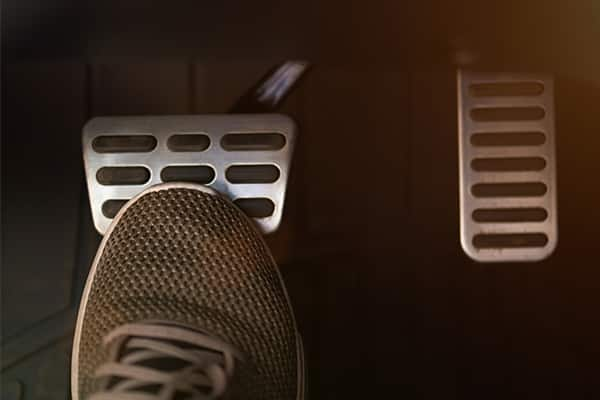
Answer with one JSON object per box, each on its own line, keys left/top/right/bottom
{"left": 0, "top": 0, "right": 600, "bottom": 400}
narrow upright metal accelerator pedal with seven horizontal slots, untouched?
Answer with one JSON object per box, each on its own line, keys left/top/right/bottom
{"left": 458, "top": 71, "right": 557, "bottom": 262}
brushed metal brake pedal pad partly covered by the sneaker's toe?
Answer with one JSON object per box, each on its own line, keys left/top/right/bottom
{"left": 83, "top": 114, "right": 296, "bottom": 234}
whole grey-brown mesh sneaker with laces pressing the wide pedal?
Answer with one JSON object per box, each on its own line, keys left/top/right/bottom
{"left": 71, "top": 183, "right": 304, "bottom": 400}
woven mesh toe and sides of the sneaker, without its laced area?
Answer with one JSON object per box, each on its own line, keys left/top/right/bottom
{"left": 73, "top": 188, "right": 301, "bottom": 399}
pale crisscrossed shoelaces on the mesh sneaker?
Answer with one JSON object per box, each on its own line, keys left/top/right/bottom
{"left": 88, "top": 323, "right": 241, "bottom": 400}
